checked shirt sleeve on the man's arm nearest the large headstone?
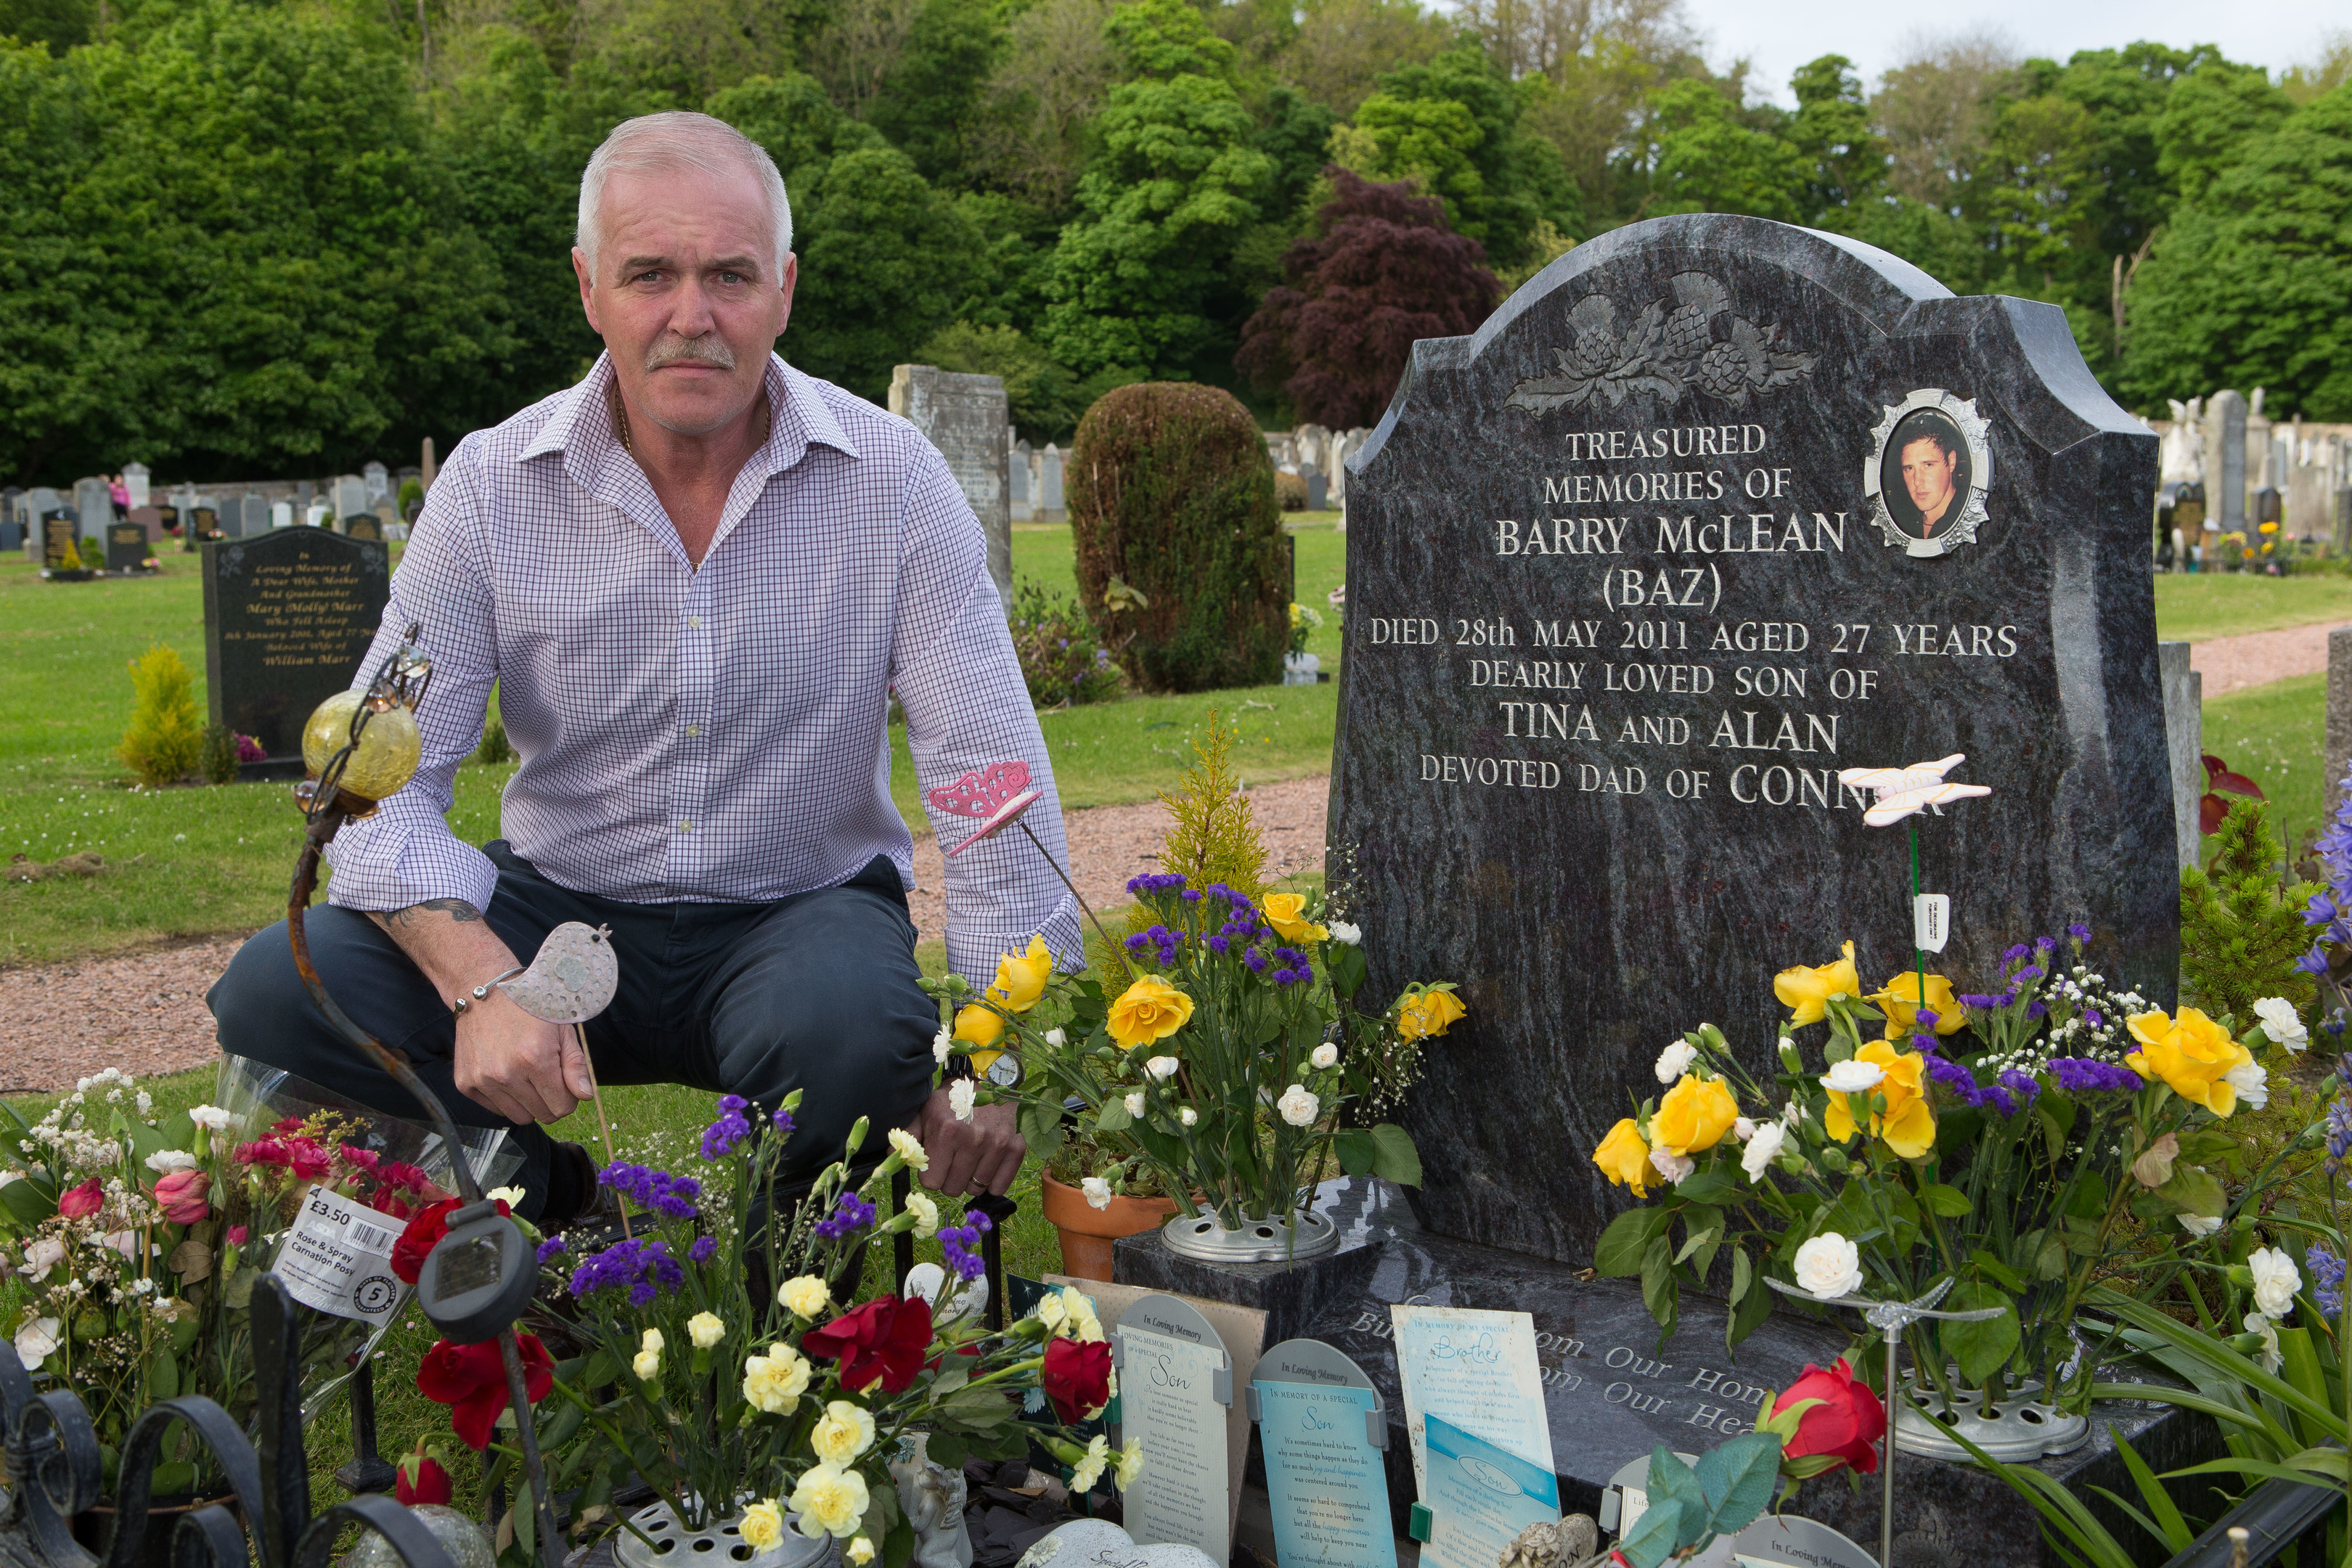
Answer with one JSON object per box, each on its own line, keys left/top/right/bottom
{"left": 891, "top": 449, "right": 1085, "bottom": 985}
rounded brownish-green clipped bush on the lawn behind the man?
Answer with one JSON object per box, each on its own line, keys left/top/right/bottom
{"left": 1063, "top": 381, "right": 1291, "bottom": 691}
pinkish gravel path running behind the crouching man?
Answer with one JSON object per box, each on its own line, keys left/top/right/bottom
{"left": 0, "top": 778, "right": 1331, "bottom": 1093}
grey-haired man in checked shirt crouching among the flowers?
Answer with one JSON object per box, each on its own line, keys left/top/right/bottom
{"left": 209, "top": 113, "right": 1079, "bottom": 1227}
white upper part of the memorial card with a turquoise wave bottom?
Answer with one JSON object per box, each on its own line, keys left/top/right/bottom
{"left": 1388, "top": 1307, "right": 1552, "bottom": 1500}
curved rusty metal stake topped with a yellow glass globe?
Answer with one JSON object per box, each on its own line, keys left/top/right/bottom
{"left": 287, "top": 623, "right": 562, "bottom": 1568}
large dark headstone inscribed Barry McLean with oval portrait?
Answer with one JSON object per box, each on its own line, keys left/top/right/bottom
{"left": 1331, "top": 216, "right": 2180, "bottom": 1265}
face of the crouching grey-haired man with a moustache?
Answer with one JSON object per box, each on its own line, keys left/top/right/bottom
{"left": 571, "top": 169, "right": 800, "bottom": 435}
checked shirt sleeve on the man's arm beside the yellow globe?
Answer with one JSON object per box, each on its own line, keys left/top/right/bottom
{"left": 327, "top": 437, "right": 499, "bottom": 910}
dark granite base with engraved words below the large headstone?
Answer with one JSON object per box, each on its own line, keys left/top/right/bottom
{"left": 1113, "top": 1180, "right": 2223, "bottom": 1568}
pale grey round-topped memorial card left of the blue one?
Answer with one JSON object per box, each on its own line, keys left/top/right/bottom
{"left": 1115, "top": 1323, "right": 1233, "bottom": 1564}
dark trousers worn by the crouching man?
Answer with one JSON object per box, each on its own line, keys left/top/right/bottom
{"left": 207, "top": 839, "right": 939, "bottom": 1220}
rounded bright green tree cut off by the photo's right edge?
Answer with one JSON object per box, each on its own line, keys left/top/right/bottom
{"left": 2121, "top": 87, "right": 2352, "bottom": 418}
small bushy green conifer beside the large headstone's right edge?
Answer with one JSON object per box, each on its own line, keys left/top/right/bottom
{"left": 2180, "top": 797, "right": 2319, "bottom": 1027}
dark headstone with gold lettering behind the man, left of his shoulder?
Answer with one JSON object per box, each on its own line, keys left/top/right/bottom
{"left": 205, "top": 529, "right": 391, "bottom": 771}
